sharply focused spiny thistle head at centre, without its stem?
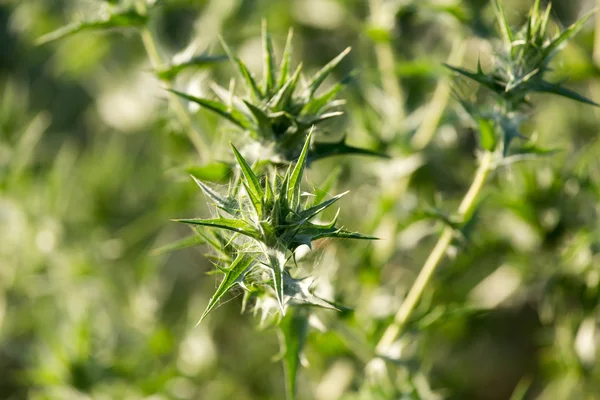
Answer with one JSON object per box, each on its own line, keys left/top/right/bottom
{"left": 172, "top": 133, "right": 375, "bottom": 322}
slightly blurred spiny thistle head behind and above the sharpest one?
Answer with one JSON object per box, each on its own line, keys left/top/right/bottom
{"left": 173, "top": 22, "right": 380, "bottom": 164}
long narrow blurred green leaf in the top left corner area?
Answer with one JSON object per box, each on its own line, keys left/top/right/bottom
{"left": 35, "top": 8, "right": 148, "bottom": 46}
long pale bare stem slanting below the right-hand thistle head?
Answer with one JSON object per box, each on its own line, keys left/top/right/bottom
{"left": 376, "top": 152, "right": 493, "bottom": 354}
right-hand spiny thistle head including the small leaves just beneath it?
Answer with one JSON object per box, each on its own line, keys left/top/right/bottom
{"left": 447, "top": 0, "right": 598, "bottom": 157}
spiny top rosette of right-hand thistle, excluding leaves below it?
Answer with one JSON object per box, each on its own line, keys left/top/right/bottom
{"left": 447, "top": 0, "right": 597, "bottom": 111}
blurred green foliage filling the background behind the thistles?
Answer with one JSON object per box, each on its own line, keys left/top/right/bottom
{"left": 0, "top": 0, "right": 600, "bottom": 400}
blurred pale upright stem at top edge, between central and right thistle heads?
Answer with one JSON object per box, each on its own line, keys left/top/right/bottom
{"left": 369, "top": 0, "right": 405, "bottom": 134}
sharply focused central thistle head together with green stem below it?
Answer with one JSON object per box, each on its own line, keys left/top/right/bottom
{"left": 162, "top": 132, "right": 375, "bottom": 399}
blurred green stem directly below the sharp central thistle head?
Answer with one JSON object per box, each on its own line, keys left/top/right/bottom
{"left": 279, "top": 309, "right": 308, "bottom": 400}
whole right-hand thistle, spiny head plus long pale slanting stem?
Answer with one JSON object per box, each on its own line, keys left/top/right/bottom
{"left": 377, "top": 0, "right": 598, "bottom": 353}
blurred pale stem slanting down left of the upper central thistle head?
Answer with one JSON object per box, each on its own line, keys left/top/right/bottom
{"left": 140, "top": 27, "right": 209, "bottom": 161}
